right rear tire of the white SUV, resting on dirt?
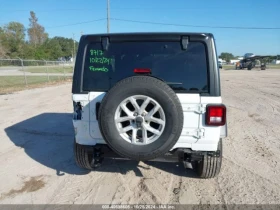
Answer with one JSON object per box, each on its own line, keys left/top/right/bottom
{"left": 196, "top": 139, "right": 223, "bottom": 179}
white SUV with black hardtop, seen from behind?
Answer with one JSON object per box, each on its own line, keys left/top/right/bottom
{"left": 72, "top": 33, "right": 227, "bottom": 178}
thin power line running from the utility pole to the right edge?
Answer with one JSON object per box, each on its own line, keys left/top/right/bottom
{"left": 111, "top": 18, "right": 280, "bottom": 30}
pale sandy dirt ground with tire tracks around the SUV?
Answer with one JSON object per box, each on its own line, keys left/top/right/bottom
{"left": 0, "top": 70, "right": 280, "bottom": 204}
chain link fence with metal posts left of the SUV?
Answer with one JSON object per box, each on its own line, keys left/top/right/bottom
{"left": 0, "top": 58, "right": 74, "bottom": 89}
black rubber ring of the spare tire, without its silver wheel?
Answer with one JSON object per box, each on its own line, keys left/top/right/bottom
{"left": 99, "top": 78, "right": 183, "bottom": 160}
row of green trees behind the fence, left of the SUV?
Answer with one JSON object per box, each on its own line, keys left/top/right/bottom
{"left": 0, "top": 11, "right": 78, "bottom": 60}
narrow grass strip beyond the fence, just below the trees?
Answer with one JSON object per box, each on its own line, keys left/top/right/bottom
{"left": 21, "top": 66, "right": 73, "bottom": 74}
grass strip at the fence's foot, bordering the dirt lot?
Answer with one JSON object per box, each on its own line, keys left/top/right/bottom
{"left": 0, "top": 76, "right": 72, "bottom": 94}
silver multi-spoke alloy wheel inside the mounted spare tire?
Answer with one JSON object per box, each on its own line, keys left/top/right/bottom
{"left": 115, "top": 95, "right": 165, "bottom": 145}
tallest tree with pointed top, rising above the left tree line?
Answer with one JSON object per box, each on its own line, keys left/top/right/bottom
{"left": 28, "top": 11, "right": 48, "bottom": 47}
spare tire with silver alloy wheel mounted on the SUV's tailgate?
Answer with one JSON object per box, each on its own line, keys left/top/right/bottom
{"left": 98, "top": 76, "right": 184, "bottom": 161}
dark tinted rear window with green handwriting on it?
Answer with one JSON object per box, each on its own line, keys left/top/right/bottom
{"left": 83, "top": 42, "right": 209, "bottom": 92}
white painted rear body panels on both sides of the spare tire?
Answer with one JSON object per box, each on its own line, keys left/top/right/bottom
{"left": 73, "top": 92, "right": 226, "bottom": 151}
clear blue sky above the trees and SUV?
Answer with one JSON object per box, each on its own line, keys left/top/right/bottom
{"left": 0, "top": 0, "right": 280, "bottom": 56}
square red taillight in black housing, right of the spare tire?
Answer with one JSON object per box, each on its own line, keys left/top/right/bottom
{"left": 206, "top": 105, "right": 226, "bottom": 126}
